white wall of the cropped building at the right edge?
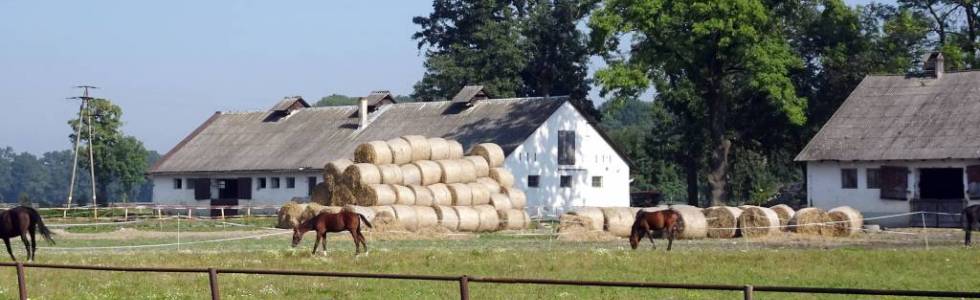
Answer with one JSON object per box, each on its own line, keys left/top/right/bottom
{"left": 807, "top": 160, "right": 980, "bottom": 226}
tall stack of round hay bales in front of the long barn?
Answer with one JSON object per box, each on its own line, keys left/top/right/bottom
{"left": 315, "top": 135, "right": 530, "bottom": 232}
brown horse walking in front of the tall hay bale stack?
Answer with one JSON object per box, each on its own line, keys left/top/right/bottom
{"left": 293, "top": 211, "right": 374, "bottom": 255}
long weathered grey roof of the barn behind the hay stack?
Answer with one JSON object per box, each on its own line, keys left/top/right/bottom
{"left": 149, "top": 97, "right": 626, "bottom": 174}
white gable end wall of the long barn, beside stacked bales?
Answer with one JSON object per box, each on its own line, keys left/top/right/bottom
{"left": 504, "top": 103, "right": 630, "bottom": 216}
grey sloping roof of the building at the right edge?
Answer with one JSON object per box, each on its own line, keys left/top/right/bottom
{"left": 796, "top": 71, "right": 980, "bottom": 161}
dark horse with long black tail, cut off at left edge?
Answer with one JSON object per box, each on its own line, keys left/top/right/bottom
{"left": 0, "top": 206, "right": 54, "bottom": 261}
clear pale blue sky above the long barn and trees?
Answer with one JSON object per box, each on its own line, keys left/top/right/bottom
{"left": 0, "top": 0, "right": 888, "bottom": 154}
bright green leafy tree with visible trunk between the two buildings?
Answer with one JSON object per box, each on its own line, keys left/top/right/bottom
{"left": 590, "top": 0, "right": 806, "bottom": 204}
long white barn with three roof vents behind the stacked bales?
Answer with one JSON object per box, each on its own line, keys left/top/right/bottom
{"left": 149, "top": 86, "right": 630, "bottom": 215}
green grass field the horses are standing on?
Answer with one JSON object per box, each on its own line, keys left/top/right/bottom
{"left": 0, "top": 219, "right": 980, "bottom": 299}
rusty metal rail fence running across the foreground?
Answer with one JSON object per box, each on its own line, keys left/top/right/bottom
{"left": 0, "top": 262, "right": 980, "bottom": 300}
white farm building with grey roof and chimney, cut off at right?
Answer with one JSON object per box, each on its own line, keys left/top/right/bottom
{"left": 796, "top": 54, "right": 980, "bottom": 227}
